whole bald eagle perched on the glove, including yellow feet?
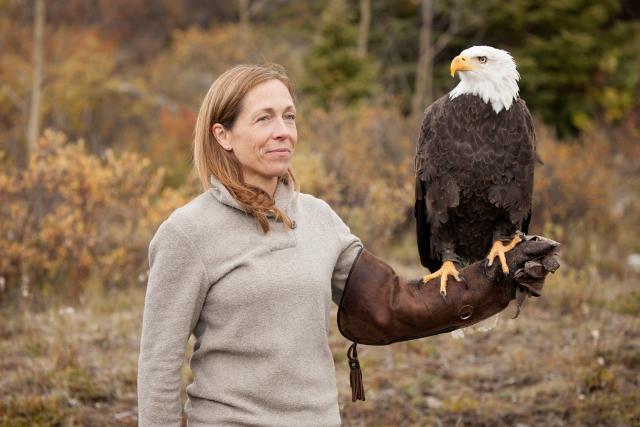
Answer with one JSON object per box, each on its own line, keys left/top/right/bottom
{"left": 415, "top": 46, "right": 537, "bottom": 300}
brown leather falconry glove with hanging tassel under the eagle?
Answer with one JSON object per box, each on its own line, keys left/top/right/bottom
{"left": 338, "top": 236, "right": 560, "bottom": 401}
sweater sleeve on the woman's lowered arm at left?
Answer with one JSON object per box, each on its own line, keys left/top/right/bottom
{"left": 138, "top": 221, "right": 208, "bottom": 427}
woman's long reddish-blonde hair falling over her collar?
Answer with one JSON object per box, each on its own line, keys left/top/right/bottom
{"left": 193, "top": 64, "right": 299, "bottom": 233}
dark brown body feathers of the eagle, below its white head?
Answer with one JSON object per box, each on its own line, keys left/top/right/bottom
{"left": 415, "top": 94, "right": 536, "bottom": 271}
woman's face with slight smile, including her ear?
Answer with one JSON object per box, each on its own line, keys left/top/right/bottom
{"left": 212, "top": 79, "right": 298, "bottom": 194}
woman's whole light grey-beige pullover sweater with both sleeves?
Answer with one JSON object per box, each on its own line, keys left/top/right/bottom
{"left": 138, "top": 178, "right": 362, "bottom": 427}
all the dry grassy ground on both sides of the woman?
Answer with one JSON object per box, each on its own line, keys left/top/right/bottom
{"left": 0, "top": 266, "right": 640, "bottom": 427}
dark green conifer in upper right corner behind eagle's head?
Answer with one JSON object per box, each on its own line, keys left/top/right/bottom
{"left": 481, "top": 0, "right": 640, "bottom": 137}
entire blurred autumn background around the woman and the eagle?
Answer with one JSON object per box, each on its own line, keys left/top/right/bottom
{"left": 0, "top": 0, "right": 640, "bottom": 427}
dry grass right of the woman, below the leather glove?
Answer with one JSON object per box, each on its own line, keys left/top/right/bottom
{"left": 332, "top": 266, "right": 640, "bottom": 426}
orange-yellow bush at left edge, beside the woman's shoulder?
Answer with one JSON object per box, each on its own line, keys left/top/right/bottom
{"left": 0, "top": 131, "right": 188, "bottom": 300}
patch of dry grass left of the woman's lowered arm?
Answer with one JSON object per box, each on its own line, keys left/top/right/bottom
{"left": 0, "top": 290, "right": 143, "bottom": 426}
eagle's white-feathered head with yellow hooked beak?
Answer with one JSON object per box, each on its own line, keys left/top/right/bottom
{"left": 449, "top": 46, "right": 520, "bottom": 113}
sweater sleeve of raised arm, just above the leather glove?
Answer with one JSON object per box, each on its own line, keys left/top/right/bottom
{"left": 331, "top": 209, "right": 362, "bottom": 305}
